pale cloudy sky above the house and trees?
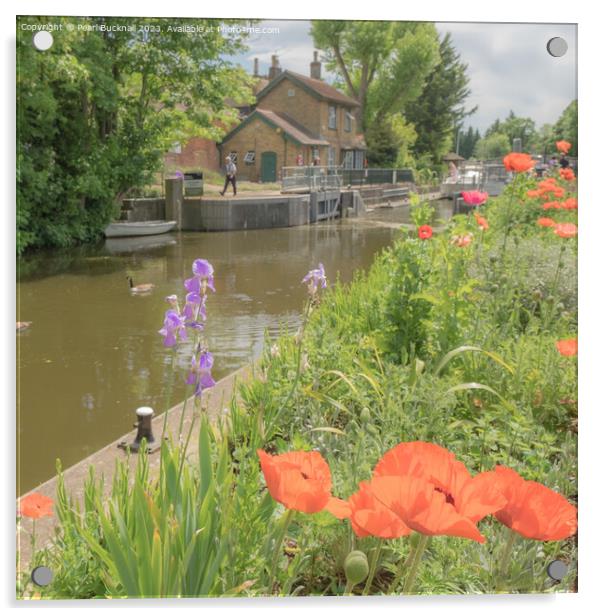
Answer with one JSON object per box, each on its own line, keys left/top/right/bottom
{"left": 226, "top": 20, "right": 577, "bottom": 132}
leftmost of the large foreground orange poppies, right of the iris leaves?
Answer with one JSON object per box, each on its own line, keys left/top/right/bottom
{"left": 257, "top": 449, "right": 346, "bottom": 517}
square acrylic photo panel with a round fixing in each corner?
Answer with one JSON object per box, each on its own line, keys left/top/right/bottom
{"left": 16, "top": 16, "right": 578, "bottom": 599}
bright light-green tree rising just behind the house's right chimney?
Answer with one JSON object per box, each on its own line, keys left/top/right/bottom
{"left": 311, "top": 20, "right": 439, "bottom": 133}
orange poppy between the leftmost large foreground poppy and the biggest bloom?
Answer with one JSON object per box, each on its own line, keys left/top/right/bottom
{"left": 348, "top": 481, "right": 412, "bottom": 539}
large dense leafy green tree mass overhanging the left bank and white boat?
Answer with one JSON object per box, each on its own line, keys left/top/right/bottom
{"left": 17, "top": 17, "right": 251, "bottom": 252}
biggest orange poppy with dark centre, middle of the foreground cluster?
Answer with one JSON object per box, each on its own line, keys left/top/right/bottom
{"left": 371, "top": 441, "right": 505, "bottom": 542}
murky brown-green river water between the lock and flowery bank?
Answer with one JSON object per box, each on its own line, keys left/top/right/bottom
{"left": 17, "top": 202, "right": 451, "bottom": 494}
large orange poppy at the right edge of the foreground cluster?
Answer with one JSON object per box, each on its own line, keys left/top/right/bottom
{"left": 480, "top": 466, "right": 577, "bottom": 541}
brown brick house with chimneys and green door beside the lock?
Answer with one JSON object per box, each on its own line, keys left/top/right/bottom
{"left": 219, "top": 52, "right": 366, "bottom": 182}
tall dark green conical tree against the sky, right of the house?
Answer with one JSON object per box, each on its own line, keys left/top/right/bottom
{"left": 405, "top": 32, "right": 477, "bottom": 163}
